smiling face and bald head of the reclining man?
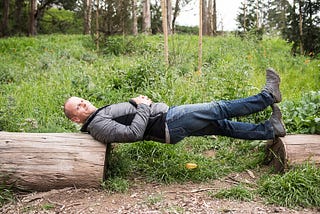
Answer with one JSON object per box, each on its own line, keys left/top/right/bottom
{"left": 65, "top": 97, "right": 96, "bottom": 123}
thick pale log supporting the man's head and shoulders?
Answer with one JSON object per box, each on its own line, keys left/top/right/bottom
{"left": 0, "top": 132, "right": 106, "bottom": 191}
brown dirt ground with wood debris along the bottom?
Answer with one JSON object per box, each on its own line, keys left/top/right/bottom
{"left": 0, "top": 171, "right": 320, "bottom": 214}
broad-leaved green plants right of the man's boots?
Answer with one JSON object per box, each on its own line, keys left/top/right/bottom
{"left": 281, "top": 91, "right": 320, "bottom": 134}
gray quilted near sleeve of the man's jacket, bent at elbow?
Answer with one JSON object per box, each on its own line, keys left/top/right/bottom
{"left": 89, "top": 104, "right": 151, "bottom": 143}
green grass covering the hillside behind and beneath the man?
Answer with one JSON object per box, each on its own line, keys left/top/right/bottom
{"left": 0, "top": 35, "right": 320, "bottom": 208}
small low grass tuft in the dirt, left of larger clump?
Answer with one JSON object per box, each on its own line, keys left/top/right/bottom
{"left": 213, "top": 184, "right": 254, "bottom": 201}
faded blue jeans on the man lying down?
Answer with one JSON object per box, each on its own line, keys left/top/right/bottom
{"left": 166, "top": 91, "right": 274, "bottom": 144}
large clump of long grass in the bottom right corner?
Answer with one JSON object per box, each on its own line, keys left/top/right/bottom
{"left": 258, "top": 165, "right": 320, "bottom": 207}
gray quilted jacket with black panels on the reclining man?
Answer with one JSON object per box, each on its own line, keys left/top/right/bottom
{"left": 81, "top": 102, "right": 169, "bottom": 143}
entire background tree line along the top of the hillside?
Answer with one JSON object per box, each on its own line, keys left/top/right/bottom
{"left": 0, "top": 0, "right": 320, "bottom": 55}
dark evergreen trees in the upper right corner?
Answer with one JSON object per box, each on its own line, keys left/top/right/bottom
{"left": 237, "top": 0, "right": 320, "bottom": 56}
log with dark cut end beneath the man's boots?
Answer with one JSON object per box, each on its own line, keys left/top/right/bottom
{"left": 266, "top": 135, "right": 320, "bottom": 172}
